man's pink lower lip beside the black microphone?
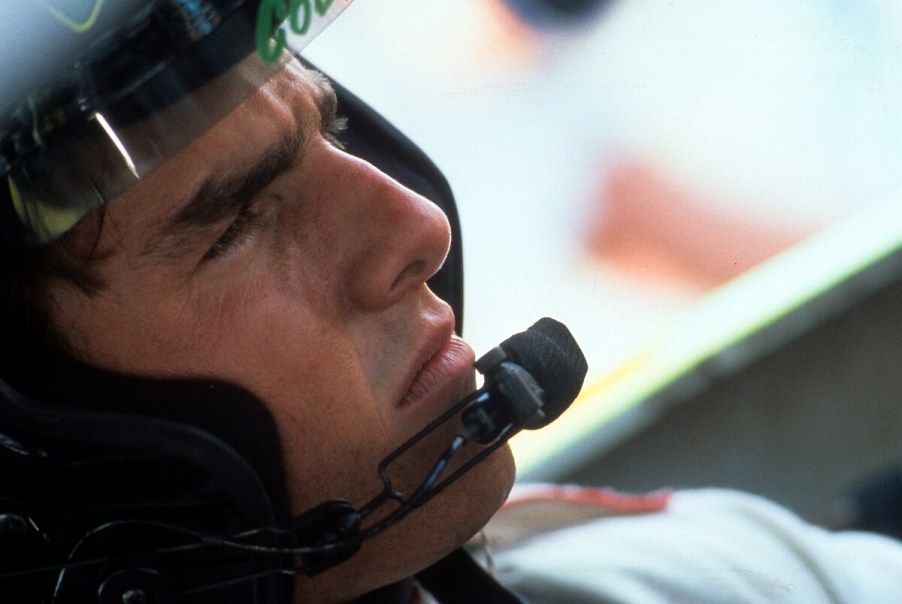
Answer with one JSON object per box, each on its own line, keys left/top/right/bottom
{"left": 398, "top": 335, "right": 475, "bottom": 407}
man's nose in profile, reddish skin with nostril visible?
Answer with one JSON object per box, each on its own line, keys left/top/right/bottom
{"left": 338, "top": 151, "right": 451, "bottom": 310}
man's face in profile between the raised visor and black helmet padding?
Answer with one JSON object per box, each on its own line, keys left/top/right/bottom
{"left": 51, "top": 59, "right": 513, "bottom": 600}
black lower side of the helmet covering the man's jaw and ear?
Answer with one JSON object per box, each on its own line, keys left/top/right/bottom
{"left": 0, "top": 346, "right": 290, "bottom": 603}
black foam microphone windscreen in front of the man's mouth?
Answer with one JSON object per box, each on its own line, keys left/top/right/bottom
{"left": 501, "top": 317, "right": 589, "bottom": 429}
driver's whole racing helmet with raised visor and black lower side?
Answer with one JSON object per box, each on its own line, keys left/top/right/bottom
{"left": 0, "top": 0, "right": 463, "bottom": 603}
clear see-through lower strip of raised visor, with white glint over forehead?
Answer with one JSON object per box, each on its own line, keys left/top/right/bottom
{"left": 4, "top": 0, "right": 351, "bottom": 245}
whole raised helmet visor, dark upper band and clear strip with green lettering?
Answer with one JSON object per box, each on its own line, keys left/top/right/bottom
{"left": 0, "top": 0, "right": 351, "bottom": 245}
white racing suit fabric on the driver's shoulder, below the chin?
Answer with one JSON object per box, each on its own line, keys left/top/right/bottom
{"left": 488, "top": 489, "right": 902, "bottom": 604}
